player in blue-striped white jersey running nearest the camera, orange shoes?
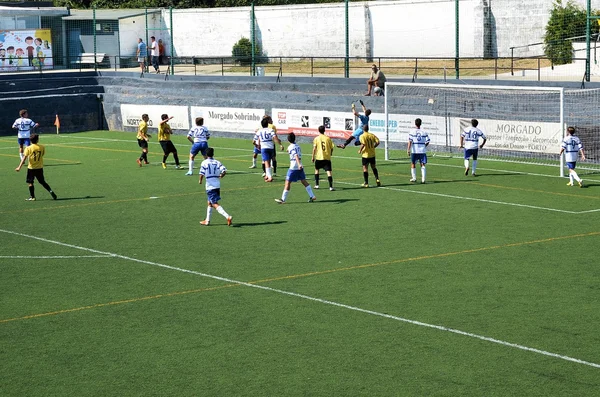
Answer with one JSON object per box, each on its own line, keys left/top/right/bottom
{"left": 198, "top": 147, "right": 232, "bottom": 226}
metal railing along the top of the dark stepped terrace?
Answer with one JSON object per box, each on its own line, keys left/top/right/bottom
{"left": 0, "top": 54, "right": 585, "bottom": 81}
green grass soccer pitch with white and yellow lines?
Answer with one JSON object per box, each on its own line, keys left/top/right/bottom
{"left": 0, "top": 131, "right": 600, "bottom": 396}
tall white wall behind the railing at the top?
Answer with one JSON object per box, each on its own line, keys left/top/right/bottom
{"left": 156, "top": 0, "right": 600, "bottom": 58}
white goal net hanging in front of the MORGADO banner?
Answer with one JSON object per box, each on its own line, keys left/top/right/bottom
{"left": 383, "top": 82, "right": 600, "bottom": 175}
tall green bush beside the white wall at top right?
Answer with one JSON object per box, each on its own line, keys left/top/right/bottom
{"left": 544, "top": 0, "right": 587, "bottom": 65}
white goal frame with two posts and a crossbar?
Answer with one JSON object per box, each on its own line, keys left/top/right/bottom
{"left": 384, "top": 81, "right": 566, "bottom": 177}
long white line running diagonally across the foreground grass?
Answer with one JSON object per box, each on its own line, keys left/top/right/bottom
{"left": 0, "top": 229, "right": 600, "bottom": 369}
